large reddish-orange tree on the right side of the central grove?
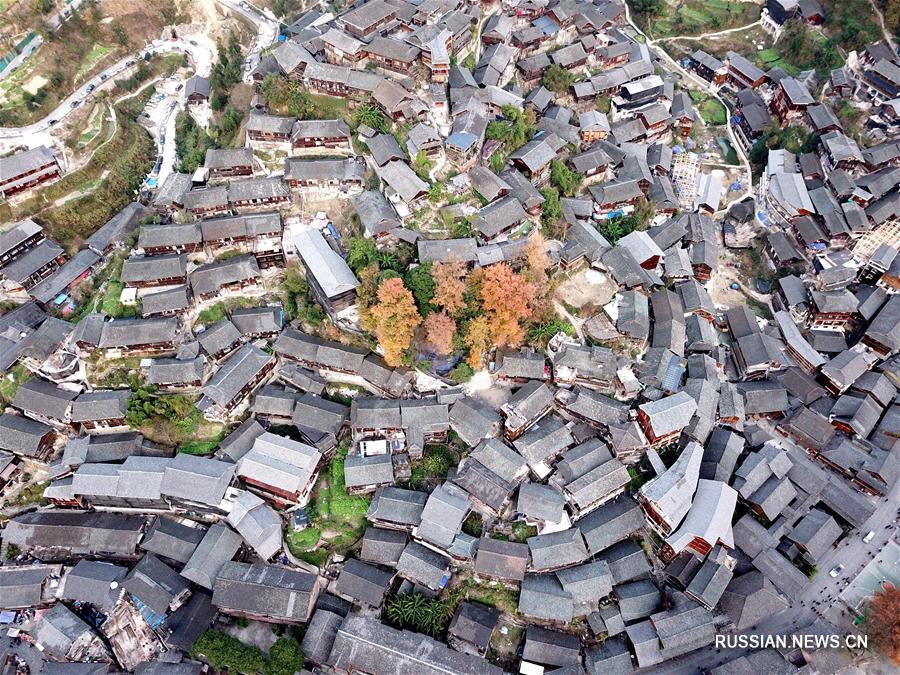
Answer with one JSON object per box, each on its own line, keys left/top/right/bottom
{"left": 479, "top": 263, "right": 534, "bottom": 347}
